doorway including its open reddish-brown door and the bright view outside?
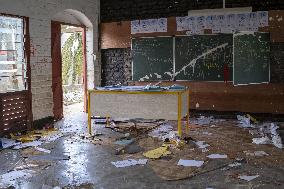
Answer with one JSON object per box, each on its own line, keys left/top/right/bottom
{"left": 52, "top": 22, "right": 87, "bottom": 120}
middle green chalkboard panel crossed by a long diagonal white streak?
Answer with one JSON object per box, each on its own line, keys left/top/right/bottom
{"left": 175, "top": 34, "right": 233, "bottom": 81}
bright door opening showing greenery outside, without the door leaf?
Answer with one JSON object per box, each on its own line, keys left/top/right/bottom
{"left": 61, "top": 24, "right": 84, "bottom": 116}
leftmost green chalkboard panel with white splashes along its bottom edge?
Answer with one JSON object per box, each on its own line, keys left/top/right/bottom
{"left": 132, "top": 37, "right": 173, "bottom": 81}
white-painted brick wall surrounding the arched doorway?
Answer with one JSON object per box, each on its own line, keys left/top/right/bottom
{"left": 0, "top": 0, "right": 100, "bottom": 120}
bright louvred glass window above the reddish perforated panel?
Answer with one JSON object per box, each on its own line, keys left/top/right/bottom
{"left": 0, "top": 16, "right": 27, "bottom": 93}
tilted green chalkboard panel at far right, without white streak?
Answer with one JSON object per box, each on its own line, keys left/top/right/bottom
{"left": 234, "top": 32, "right": 270, "bottom": 85}
